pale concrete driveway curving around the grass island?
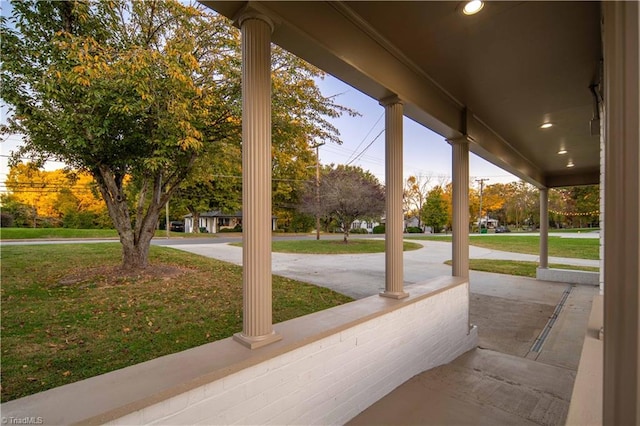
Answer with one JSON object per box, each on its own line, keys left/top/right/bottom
{"left": 154, "top": 236, "right": 598, "bottom": 303}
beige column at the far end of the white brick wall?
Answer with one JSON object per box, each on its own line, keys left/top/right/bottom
{"left": 447, "top": 137, "right": 469, "bottom": 278}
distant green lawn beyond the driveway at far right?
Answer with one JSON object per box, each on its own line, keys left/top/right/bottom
{"left": 407, "top": 235, "right": 600, "bottom": 259}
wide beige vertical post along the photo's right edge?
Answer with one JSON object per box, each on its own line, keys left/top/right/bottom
{"left": 602, "top": 1, "right": 640, "bottom": 425}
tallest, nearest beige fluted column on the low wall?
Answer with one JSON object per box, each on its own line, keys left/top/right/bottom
{"left": 233, "top": 14, "right": 282, "bottom": 349}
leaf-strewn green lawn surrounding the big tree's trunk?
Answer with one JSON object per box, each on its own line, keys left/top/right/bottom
{"left": 1, "top": 243, "right": 351, "bottom": 402}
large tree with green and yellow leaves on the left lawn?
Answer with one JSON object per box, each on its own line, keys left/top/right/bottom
{"left": 1, "top": 0, "right": 350, "bottom": 269}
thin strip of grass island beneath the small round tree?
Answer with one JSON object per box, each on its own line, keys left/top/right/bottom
{"left": 232, "top": 239, "right": 422, "bottom": 254}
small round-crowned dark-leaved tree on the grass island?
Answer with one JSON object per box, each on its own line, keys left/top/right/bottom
{"left": 301, "top": 165, "right": 385, "bottom": 243}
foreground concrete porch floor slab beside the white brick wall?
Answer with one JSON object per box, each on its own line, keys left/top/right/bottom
{"left": 349, "top": 348, "right": 575, "bottom": 426}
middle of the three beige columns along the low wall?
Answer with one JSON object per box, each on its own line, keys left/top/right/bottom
{"left": 380, "top": 96, "right": 409, "bottom": 299}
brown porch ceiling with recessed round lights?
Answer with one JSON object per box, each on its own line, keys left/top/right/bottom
{"left": 202, "top": 1, "right": 602, "bottom": 187}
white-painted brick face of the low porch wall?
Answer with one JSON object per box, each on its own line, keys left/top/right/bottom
{"left": 112, "top": 283, "right": 477, "bottom": 424}
